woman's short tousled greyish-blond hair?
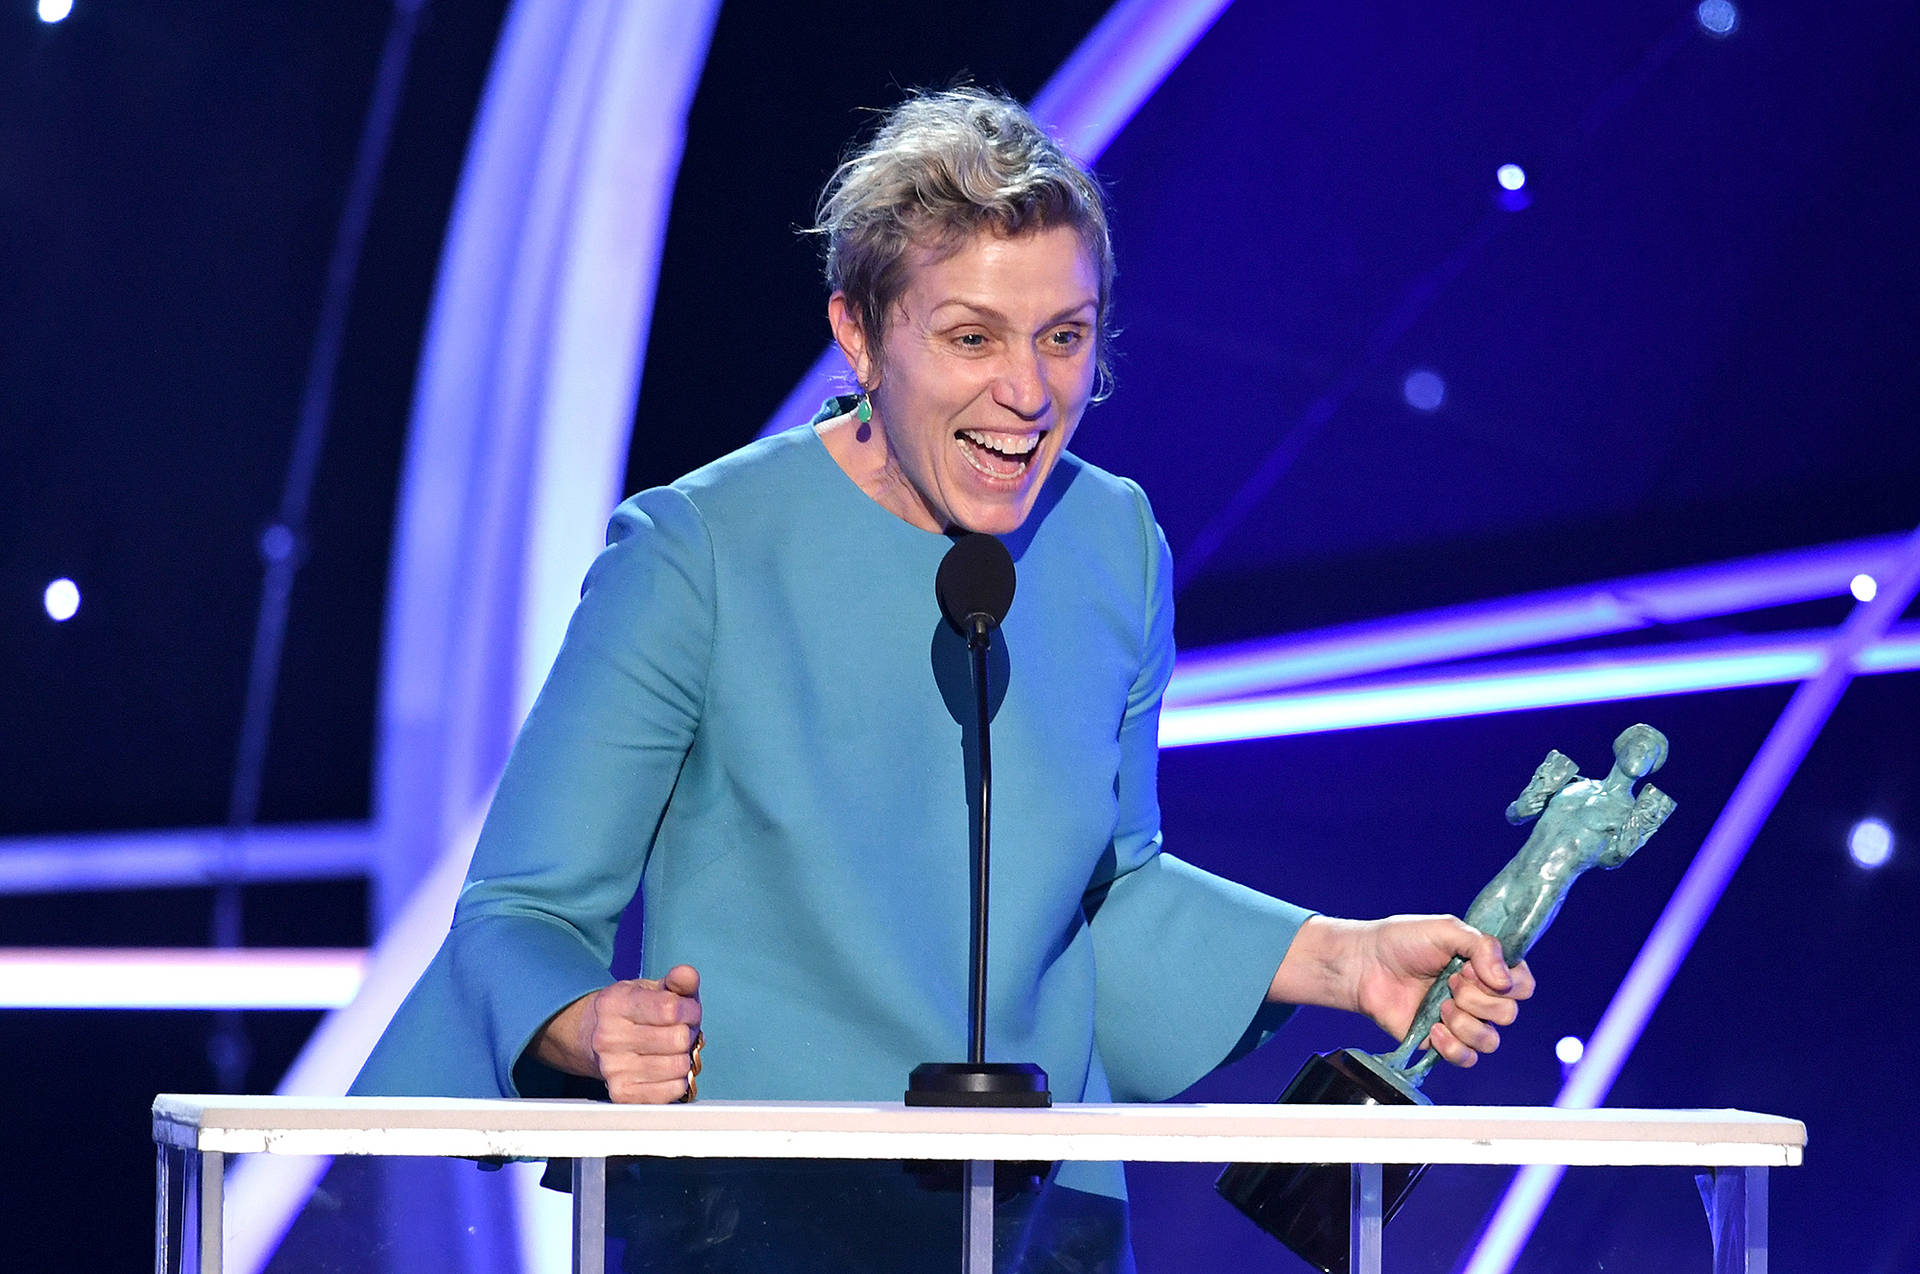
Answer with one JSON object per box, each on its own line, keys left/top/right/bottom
{"left": 812, "top": 86, "right": 1114, "bottom": 401}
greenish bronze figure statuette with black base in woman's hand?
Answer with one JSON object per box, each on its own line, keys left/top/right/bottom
{"left": 1213, "top": 725, "right": 1674, "bottom": 1274}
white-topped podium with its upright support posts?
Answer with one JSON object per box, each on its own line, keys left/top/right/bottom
{"left": 154, "top": 1094, "right": 1807, "bottom": 1274}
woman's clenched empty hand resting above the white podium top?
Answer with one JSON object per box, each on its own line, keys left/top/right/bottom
{"left": 536, "top": 965, "right": 701, "bottom": 1105}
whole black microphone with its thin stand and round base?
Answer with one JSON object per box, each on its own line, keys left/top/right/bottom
{"left": 906, "top": 531, "right": 1052, "bottom": 1105}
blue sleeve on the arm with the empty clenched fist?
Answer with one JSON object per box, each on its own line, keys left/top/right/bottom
{"left": 353, "top": 489, "right": 714, "bottom": 1096}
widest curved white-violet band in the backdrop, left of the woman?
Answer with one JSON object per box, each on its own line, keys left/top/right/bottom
{"left": 227, "top": 0, "right": 720, "bottom": 1274}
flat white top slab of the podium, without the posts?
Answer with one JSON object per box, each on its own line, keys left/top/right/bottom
{"left": 154, "top": 1094, "right": 1807, "bottom": 1167}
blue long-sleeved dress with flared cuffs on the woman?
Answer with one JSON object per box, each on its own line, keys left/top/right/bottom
{"left": 353, "top": 428, "right": 1309, "bottom": 1197}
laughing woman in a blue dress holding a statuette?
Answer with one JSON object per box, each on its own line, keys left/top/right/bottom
{"left": 355, "top": 88, "right": 1532, "bottom": 1268}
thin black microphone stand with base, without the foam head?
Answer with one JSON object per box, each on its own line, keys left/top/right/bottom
{"left": 906, "top": 612, "right": 1054, "bottom": 1105}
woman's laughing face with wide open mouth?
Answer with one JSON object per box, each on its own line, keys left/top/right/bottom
{"left": 829, "top": 226, "right": 1100, "bottom": 535}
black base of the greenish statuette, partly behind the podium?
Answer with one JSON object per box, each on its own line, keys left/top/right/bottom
{"left": 1213, "top": 1048, "right": 1432, "bottom": 1274}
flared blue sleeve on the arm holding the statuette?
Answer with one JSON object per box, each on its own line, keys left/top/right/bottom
{"left": 1087, "top": 483, "right": 1313, "bottom": 1101}
